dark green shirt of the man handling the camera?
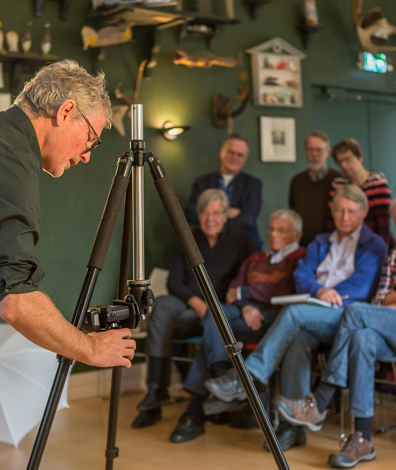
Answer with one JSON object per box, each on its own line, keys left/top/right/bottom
{"left": 0, "top": 107, "right": 45, "bottom": 300}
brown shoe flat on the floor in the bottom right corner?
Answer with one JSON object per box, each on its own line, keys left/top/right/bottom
{"left": 327, "top": 431, "right": 375, "bottom": 468}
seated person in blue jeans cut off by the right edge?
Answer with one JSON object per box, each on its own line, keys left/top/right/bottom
{"left": 276, "top": 200, "right": 396, "bottom": 468}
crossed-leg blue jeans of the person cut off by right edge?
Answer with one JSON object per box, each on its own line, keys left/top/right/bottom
{"left": 322, "top": 302, "right": 396, "bottom": 418}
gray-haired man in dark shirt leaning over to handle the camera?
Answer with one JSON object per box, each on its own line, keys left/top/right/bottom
{"left": 0, "top": 61, "right": 136, "bottom": 367}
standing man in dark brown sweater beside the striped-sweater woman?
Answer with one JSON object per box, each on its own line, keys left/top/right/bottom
{"left": 289, "top": 131, "right": 340, "bottom": 246}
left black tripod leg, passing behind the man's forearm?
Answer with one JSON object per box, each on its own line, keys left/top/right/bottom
{"left": 27, "top": 157, "right": 132, "bottom": 470}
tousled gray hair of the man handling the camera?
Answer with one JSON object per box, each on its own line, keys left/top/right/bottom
{"left": 14, "top": 60, "right": 112, "bottom": 129}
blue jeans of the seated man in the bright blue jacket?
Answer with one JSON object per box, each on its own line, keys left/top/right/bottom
{"left": 246, "top": 303, "right": 344, "bottom": 396}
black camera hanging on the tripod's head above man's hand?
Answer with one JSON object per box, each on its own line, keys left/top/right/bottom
{"left": 83, "top": 281, "right": 155, "bottom": 333}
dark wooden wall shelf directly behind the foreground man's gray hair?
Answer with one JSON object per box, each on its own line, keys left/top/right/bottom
{"left": 0, "top": 52, "right": 62, "bottom": 95}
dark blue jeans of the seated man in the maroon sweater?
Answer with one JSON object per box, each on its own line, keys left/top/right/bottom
{"left": 184, "top": 303, "right": 278, "bottom": 396}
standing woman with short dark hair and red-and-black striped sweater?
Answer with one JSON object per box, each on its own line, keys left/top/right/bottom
{"left": 326, "top": 139, "right": 396, "bottom": 250}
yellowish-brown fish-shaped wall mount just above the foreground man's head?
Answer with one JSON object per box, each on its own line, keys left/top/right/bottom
{"left": 81, "top": 23, "right": 133, "bottom": 51}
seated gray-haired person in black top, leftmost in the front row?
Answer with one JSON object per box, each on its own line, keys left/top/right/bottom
{"left": 132, "top": 189, "right": 253, "bottom": 428}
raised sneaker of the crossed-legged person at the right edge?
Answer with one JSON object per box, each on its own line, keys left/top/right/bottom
{"left": 274, "top": 393, "right": 328, "bottom": 432}
